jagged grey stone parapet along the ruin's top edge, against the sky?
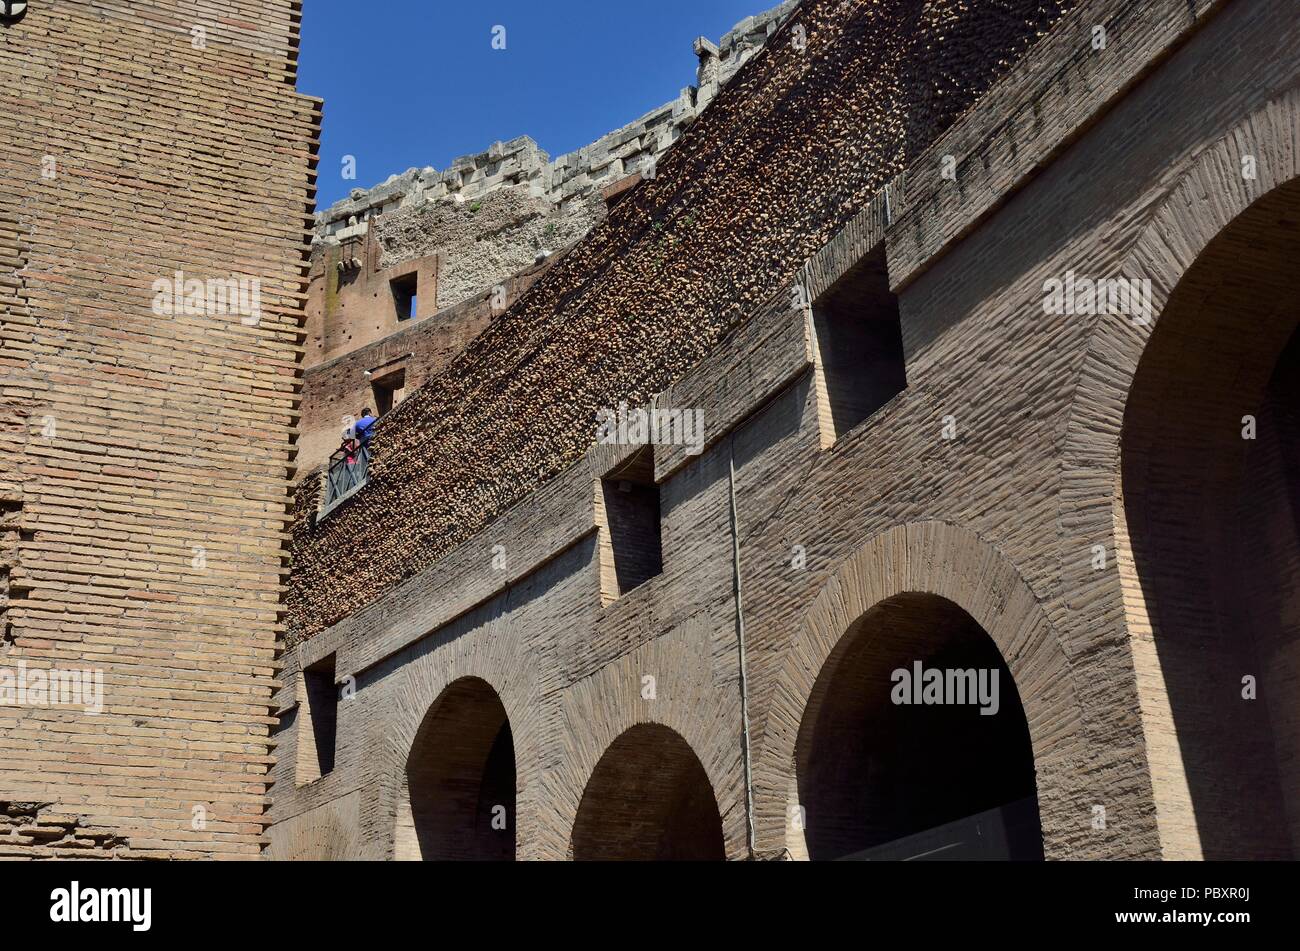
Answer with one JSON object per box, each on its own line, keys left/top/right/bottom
{"left": 316, "top": 0, "right": 800, "bottom": 240}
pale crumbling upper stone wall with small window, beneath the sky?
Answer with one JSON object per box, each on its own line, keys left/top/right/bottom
{"left": 295, "top": 0, "right": 796, "bottom": 366}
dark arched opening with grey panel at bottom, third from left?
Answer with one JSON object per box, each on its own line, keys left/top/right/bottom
{"left": 788, "top": 594, "right": 1043, "bottom": 860}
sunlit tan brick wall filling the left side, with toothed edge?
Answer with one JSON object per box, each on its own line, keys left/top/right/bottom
{"left": 0, "top": 0, "right": 320, "bottom": 857}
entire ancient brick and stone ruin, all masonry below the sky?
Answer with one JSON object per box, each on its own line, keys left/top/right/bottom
{"left": 0, "top": 0, "right": 1300, "bottom": 860}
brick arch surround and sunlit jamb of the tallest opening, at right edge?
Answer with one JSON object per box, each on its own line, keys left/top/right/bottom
{"left": 1061, "top": 90, "right": 1300, "bottom": 859}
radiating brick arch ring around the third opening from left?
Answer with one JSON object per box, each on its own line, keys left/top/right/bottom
{"left": 754, "top": 521, "right": 1089, "bottom": 859}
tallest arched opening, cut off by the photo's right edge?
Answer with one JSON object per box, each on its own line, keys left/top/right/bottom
{"left": 1118, "top": 174, "right": 1300, "bottom": 859}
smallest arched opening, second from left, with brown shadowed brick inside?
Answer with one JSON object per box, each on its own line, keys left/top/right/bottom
{"left": 572, "top": 724, "right": 727, "bottom": 861}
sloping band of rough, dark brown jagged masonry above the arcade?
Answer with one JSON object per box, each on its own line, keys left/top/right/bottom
{"left": 290, "top": 0, "right": 1070, "bottom": 642}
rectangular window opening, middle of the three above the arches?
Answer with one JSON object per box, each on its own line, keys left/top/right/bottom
{"left": 598, "top": 446, "right": 663, "bottom": 604}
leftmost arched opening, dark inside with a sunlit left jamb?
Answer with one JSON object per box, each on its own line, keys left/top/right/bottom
{"left": 394, "top": 678, "right": 515, "bottom": 861}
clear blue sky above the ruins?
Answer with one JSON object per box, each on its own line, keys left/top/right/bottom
{"left": 298, "top": 0, "right": 777, "bottom": 208}
